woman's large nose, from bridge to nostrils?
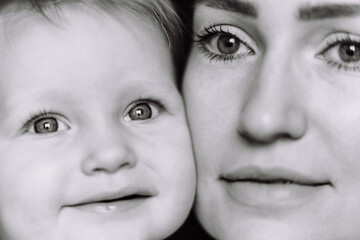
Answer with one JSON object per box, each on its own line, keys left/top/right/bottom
{"left": 238, "top": 56, "right": 307, "bottom": 144}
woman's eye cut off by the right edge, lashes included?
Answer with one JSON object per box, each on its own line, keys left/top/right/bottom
{"left": 319, "top": 33, "right": 360, "bottom": 71}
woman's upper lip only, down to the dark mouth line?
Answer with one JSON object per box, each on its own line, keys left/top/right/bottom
{"left": 220, "top": 167, "right": 332, "bottom": 187}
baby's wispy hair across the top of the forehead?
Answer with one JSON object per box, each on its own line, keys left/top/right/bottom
{"left": 0, "top": 1, "right": 164, "bottom": 41}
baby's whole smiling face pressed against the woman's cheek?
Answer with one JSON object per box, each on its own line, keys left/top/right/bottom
{"left": 0, "top": 6, "right": 195, "bottom": 240}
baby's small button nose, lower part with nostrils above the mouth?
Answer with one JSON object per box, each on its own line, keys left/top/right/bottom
{"left": 81, "top": 126, "right": 137, "bottom": 176}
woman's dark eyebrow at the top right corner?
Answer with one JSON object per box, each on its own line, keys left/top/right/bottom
{"left": 298, "top": 4, "right": 360, "bottom": 21}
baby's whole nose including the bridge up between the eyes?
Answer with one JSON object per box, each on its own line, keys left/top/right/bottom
{"left": 81, "top": 115, "right": 137, "bottom": 175}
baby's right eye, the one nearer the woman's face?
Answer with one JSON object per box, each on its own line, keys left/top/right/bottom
{"left": 125, "top": 100, "right": 162, "bottom": 122}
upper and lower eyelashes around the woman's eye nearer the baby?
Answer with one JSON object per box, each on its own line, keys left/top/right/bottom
{"left": 193, "top": 24, "right": 255, "bottom": 62}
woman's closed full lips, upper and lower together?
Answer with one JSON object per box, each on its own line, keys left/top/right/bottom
{"left": 219, "top": 167, "right": 333, "bottom": 208}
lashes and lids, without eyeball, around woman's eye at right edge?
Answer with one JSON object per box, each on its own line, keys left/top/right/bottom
{"left": 317, "top": 33, "right": 360, "bottom": 72}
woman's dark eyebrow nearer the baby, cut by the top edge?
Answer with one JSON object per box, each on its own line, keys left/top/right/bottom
{"left": 196, "top": 0, "right": 258, "bottom": 18}
